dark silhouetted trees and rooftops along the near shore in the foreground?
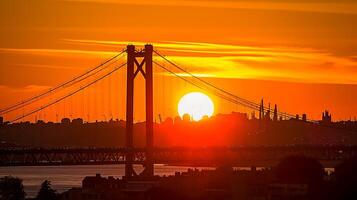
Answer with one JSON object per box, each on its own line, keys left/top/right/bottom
{"left": 0, "top": 156, "right": 357, "bottom": 200}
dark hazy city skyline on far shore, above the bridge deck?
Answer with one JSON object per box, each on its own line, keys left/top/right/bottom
{"left": 0, "top": 109, "right": 357, "bottom": 147}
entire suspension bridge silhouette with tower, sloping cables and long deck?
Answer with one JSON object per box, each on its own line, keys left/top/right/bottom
{"left": 0, "top": 44, "right": 346, "bottom": 177}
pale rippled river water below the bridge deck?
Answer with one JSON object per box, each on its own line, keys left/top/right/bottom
{"left": 0, "top": 165, "right": 211, "bottom": 197}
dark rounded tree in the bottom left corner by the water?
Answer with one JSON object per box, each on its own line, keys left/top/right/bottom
{"left": 0, "top": 176, "right": 26, "bottom": 200}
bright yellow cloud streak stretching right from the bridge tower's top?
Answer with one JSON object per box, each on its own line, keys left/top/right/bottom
{"left": 66, "top": 40, "right": 357, "bottom": 84}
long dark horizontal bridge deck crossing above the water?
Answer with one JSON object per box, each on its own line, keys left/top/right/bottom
{"left": 0, "top": 146, "right": 357, "bottom": 167}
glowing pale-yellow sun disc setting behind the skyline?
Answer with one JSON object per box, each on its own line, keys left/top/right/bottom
{"left": 177, "top": 92, "right": 214, "bottom": 121}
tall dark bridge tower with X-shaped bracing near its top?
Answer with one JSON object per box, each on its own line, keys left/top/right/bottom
{"left": 125, "top": 44, "right": 154, "bottom": 178}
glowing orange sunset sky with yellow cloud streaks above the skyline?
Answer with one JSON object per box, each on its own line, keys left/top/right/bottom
{"left": 0, "top": 0, "right": 357, "bottom": 120}
